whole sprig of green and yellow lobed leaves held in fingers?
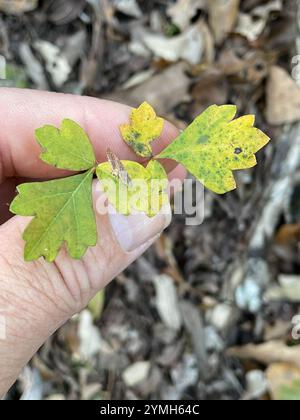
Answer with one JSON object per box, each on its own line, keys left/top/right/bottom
{"left": 10, "top": 102, "right": 269, "bottom": 262}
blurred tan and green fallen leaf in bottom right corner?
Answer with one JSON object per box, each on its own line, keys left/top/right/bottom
{"left": 266, "top": 363, "right": 300, "bottom": 401}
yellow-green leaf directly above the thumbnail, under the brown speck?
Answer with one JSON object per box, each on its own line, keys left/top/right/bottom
{"left": 97, "top": 160, "right": 169, "bottom": 217}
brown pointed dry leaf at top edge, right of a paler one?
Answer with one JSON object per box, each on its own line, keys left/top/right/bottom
{"left": 208, "top": 0, "right": 240, "bottom": 44}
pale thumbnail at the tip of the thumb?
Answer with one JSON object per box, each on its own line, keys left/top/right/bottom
{"left": 109, "top": 205, "right": 172, "bottom": 252}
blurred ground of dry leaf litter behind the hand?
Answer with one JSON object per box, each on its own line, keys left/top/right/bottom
{"left": 0, "top": 0, "right": 300, "bottom": 400}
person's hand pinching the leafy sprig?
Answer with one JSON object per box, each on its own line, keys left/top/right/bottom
{"left": 0, "top": 88, "right": 184, "bottom": 395}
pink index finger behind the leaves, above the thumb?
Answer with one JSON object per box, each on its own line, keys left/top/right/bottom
{"left": 0, "top": 88, "right": 178, "bottom": 182}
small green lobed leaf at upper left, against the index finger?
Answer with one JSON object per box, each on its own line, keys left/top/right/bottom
{"left": 36, "top": 120, "right": 96, "bottom": 171}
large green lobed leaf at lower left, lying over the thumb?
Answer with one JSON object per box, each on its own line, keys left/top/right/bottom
{"left": 10, "top": 170, "right": 97, "bottom": 262}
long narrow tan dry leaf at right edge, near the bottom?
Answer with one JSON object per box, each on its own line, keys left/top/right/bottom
{"left": 227, "top": 340, "right": 300, "bottom": 368}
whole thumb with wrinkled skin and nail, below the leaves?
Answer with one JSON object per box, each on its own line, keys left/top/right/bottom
{"left": 0, "top": 181, "right": 171, "bottom": 398}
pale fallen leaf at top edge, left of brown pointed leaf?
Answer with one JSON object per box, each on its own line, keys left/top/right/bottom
{"left": 167, "top": 0, "right": 206, "bottom": 31}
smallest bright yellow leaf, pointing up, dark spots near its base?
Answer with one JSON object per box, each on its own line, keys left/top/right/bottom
{"left": 120, "top": 102, "right": 164, "bottom": 157}
